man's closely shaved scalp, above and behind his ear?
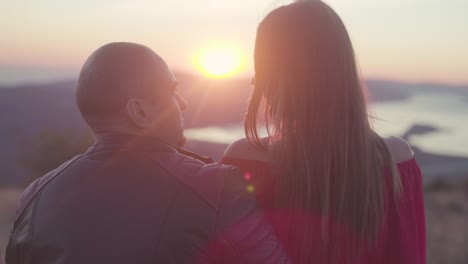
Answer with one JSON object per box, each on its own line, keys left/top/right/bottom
{"left": 76, "top": 42, "right": 185, "bottom": 144}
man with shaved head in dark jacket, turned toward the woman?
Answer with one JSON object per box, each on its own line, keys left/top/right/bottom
{"left": 6, "top": 43, "right": 285, "bottom": 264}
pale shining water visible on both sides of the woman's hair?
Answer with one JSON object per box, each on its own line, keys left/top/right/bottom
{"left": 186, "top": 91, "right": 468, "bottom": 157}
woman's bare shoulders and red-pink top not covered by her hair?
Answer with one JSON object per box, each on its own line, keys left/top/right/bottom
{"left": 222, "top": 138, "right": 426, "bottom": 264}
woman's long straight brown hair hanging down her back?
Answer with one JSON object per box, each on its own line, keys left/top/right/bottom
{"left": 245, "top": 1, "right": 401, "bottom": 263}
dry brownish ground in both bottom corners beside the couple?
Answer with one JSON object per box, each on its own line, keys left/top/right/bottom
{"left": 0, "top": 177, "right": 468, "bottom": 264}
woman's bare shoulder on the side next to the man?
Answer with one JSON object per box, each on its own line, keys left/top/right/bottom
{"left": 223, "top": 138, "right": 268, "bottom": 162}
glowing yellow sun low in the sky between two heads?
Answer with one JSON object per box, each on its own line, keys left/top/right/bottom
{"left": 195, "top": 44, "right": 245, "bottom": 78}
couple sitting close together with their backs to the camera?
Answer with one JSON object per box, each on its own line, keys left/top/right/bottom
{"left": 6, "top": 1, "right": 425, "bottom": 264}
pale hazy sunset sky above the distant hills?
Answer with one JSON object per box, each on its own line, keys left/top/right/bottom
{"left": 0, "top": 0, "right": 468, "bottom": 84}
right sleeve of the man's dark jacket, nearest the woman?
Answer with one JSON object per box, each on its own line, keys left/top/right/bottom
{"left": 205, "top": 168, "right": 288, "bottom": 263}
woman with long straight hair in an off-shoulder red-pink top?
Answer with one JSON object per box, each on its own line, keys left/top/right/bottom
{"left": 223, "top": 1, "right": 425, "bottom": 264}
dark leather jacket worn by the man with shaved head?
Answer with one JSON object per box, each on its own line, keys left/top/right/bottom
{"left": 6, "top": 136, "right": 285, "bottom": 264}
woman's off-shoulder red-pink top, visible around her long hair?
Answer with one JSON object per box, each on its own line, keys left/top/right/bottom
{"left": 221, "top": 158, "right": 426, "bottom": 264}
